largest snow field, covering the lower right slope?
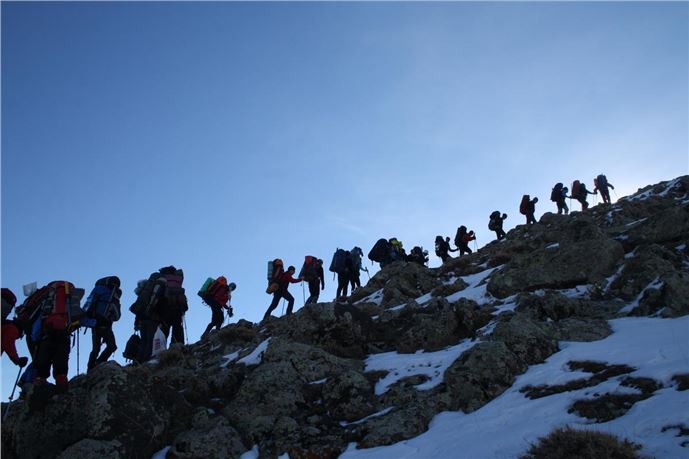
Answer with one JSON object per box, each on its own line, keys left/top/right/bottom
{"left": 340, "top": 316, "right": 689, "bottom": 459}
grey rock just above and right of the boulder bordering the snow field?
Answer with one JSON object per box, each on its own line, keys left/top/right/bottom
{"left": 491, "top": 314, "right": 559, "bottom": 365}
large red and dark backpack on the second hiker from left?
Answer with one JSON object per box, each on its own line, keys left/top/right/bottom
{"left": 40, "top": 281, "right": 84, "bottom": 331}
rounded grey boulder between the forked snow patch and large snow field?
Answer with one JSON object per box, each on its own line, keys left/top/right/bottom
{"left": 444, "top": 341, "right": 527, "bottom": 412}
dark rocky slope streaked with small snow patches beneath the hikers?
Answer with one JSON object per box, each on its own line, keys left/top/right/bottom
{"left": 2, "top": 176, "right": 689, "bottom": 459}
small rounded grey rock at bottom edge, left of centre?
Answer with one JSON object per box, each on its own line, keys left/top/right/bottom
{"left": 167, "top": 409, "right": 247, "bottom": 459}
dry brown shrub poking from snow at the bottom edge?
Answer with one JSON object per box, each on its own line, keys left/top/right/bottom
{"left": 520, "top": 427, "right": 642, "bottom": 459}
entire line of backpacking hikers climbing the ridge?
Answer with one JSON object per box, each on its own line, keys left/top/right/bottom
{"left": 2, "top": 174, "right": 615, "bottom": 398}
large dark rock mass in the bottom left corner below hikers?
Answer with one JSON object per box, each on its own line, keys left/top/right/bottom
{"left": 2, "top": 362, "right": 191, "bottom": 458}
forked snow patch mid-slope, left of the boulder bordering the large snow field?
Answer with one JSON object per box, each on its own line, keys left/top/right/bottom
{"left": 365, "top": 339, "right": 478, "bottom": 395}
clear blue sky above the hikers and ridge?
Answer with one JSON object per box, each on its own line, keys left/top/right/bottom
{"left": 1, "top": 2, "right": 689, "bottom": 399}
